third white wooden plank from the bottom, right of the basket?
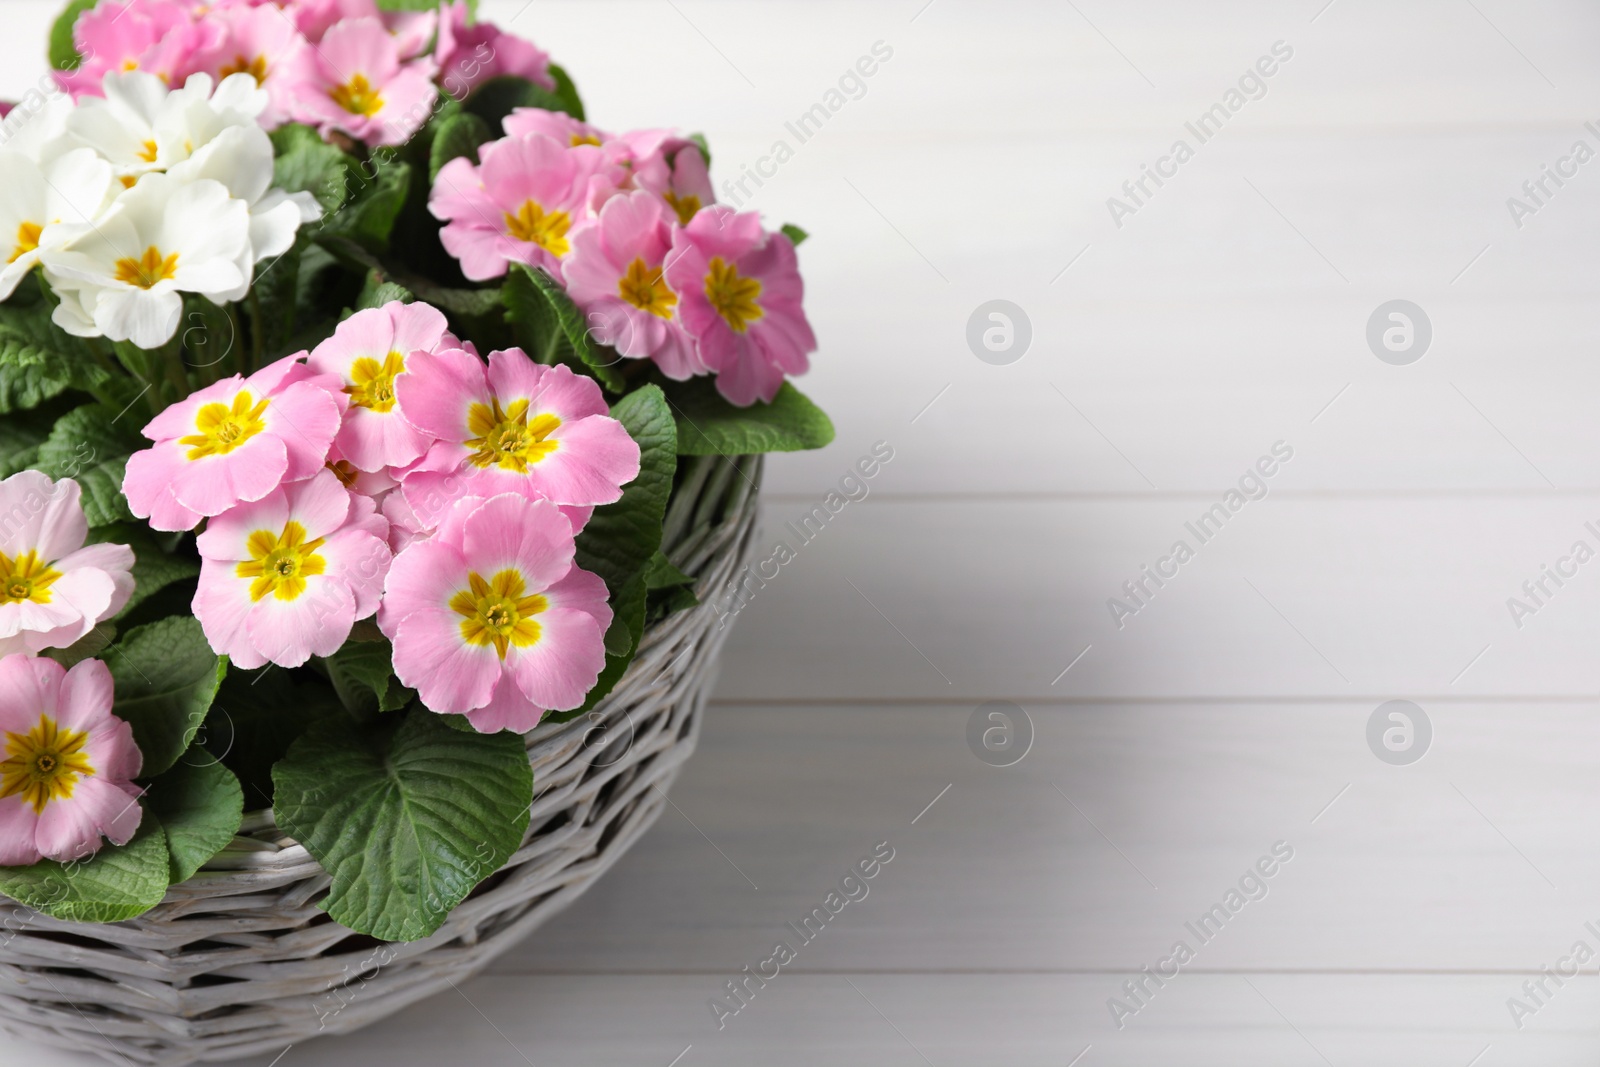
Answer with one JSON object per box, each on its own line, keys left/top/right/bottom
{"left": 718, "top": 499, "right": 1600, "bottom": 704}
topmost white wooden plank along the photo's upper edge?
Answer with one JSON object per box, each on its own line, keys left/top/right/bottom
{"left": 482, "top": 0, "right": 1600, "bottom": 139}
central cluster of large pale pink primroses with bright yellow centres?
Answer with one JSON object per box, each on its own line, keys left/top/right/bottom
{"left": 123, "top": 301, "right": 640, "bottom": 731}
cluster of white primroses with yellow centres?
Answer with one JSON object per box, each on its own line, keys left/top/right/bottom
{"left": 0, "top": 70, "right": 320, "bottom": 349}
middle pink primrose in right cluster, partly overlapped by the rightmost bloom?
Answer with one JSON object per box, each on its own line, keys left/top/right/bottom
{"left": 565, "top": 190, "right": 706, "bottom": 381}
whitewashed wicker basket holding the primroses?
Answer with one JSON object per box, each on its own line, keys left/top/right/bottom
{"left": 0, "top": 458, "right": 760, "bottom": 1065}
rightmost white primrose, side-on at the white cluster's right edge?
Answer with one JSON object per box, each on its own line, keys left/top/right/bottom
{"left": 166, "top": 123, "right": 322, "bottom": 301}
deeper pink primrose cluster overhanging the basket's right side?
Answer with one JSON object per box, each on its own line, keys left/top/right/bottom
{"left": 429, "top": 107, "right": 816, "bottom": 405}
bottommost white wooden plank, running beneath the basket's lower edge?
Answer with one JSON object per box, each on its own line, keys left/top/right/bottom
{"left": 9, "top": 974, "right": 1600, "bottom": 1067}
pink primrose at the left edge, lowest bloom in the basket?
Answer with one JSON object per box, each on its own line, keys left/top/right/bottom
{"left": 0, "top": 656, "right": 144, "bottom": 867}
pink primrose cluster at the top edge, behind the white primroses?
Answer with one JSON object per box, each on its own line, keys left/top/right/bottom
{"left": 58, "top": 0, "right": 555, "bottom": 146}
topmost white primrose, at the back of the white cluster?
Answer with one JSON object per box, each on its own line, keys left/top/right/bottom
{"left": 67, "top": 70, "right": 267, "bottom": 186}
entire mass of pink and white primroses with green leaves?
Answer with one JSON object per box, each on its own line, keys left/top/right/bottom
{"left": 0, "top": 0, "right": 832, "bottom": 966}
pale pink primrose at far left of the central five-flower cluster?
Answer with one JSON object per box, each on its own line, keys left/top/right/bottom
{"left": 122, "top": 355, "right": 344, "bottom": 530}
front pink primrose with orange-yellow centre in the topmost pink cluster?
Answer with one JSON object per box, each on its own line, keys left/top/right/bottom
{"left": 283, "top": 18, "right": 438, "bottom": 146}
